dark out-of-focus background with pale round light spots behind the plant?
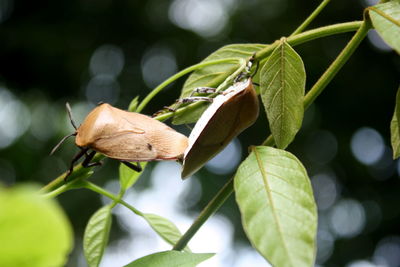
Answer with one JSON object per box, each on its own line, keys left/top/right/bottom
{"left": 0, "top": 0, "right": 400, "bottom": 267}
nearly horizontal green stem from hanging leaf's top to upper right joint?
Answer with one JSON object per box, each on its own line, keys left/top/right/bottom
{"left": 256, "top": 21, "right": 363, "bottom": 59}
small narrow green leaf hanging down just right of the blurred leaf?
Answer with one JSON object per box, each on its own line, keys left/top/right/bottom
{"left": 83, "top": 205, "right": 112, "bottom": 267}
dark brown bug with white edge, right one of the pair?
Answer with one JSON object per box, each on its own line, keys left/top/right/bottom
{"left": 181, "top": 77, "right": 259, "bottom": 179}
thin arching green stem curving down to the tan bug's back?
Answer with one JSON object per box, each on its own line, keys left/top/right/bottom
{"left": 136, "top": 58, "right": 238, "bottom": 113}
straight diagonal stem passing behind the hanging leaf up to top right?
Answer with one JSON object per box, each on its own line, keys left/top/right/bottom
{"left": 262, "top": 21, "right": 371, "bottom": 146}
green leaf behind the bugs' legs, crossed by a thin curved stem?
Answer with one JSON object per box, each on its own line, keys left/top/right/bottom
{"left": 172, "top": 44, "right": 266, "bottom": 125}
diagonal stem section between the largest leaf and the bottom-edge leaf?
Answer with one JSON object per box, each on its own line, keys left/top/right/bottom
{"left": 173, "top": 177, "right": 233, "bottom": 250}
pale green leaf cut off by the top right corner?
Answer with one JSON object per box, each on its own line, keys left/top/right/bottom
{"left": 369, "top": 1, "right": 400, "bottom": 54}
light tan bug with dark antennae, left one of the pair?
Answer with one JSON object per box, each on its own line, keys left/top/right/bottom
{"left": 51, "top": 103, "right": 188, "bottom": 177}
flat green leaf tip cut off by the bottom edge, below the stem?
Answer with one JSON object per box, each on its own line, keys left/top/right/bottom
{"left": 125, "top": 250, "right": 214, "bottom": 267}
